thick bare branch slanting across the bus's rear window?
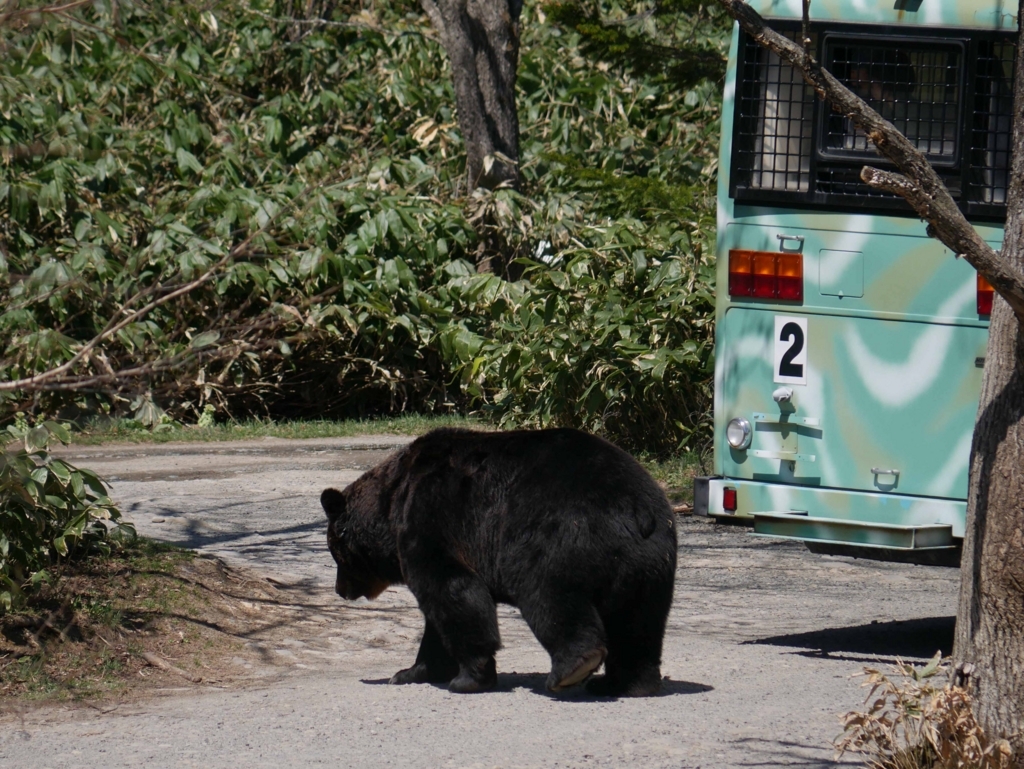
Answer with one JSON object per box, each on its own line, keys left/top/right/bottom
{"left": 718, "top": 0, "right": 1024, "bottom": 322}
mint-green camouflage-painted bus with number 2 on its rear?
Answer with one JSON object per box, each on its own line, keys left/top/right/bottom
{"left": 694, "top": 0, "right": 1017, "bottom": 564}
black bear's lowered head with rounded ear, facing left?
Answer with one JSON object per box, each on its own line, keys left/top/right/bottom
{"left": 321, "top": 488, "right": 390, "bottom": 601}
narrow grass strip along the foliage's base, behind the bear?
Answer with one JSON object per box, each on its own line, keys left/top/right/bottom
{"left": 72, "top": 415, "right": 486, "bottom": 445}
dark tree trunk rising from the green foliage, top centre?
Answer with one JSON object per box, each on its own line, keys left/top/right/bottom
{"left": 421, "top": 0, "right": 522, "bottom": 193}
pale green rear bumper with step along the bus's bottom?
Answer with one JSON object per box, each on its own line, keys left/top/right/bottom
{"left": 694, "top": 477, "right": 967, "bottom": 552}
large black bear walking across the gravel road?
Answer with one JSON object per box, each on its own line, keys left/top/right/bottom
{"left": 321, "top": 429, "right": 676, "bottom": 696}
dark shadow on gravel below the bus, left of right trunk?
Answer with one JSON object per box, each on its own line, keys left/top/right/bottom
{"left": 744, "top": 616, "right": 956, "bottom": 659}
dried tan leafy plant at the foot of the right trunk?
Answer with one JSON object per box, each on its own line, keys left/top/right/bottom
{"left": 836, "top": 652, "right": 1012, "bottom": 769}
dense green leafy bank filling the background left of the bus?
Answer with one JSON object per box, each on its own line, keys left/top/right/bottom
{"left": 0, "top": 0, "right": 724, "bottom": 451}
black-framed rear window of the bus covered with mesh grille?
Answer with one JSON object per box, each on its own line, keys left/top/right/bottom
{"left": 731, "top": 27, "right": 1014, "bottom": 219}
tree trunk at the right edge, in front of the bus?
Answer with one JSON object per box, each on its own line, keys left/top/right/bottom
{"left": 953, "top": 13, "right": 1024, "bottom": 753}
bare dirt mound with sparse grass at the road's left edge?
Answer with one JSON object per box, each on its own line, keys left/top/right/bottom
{"left": 0, "top": 539, "right": 274, "bottom": 702}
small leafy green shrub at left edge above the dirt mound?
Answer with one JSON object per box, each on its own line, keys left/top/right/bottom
{"left": 0, "top": 420, "right": 134, "bottom": 613}
